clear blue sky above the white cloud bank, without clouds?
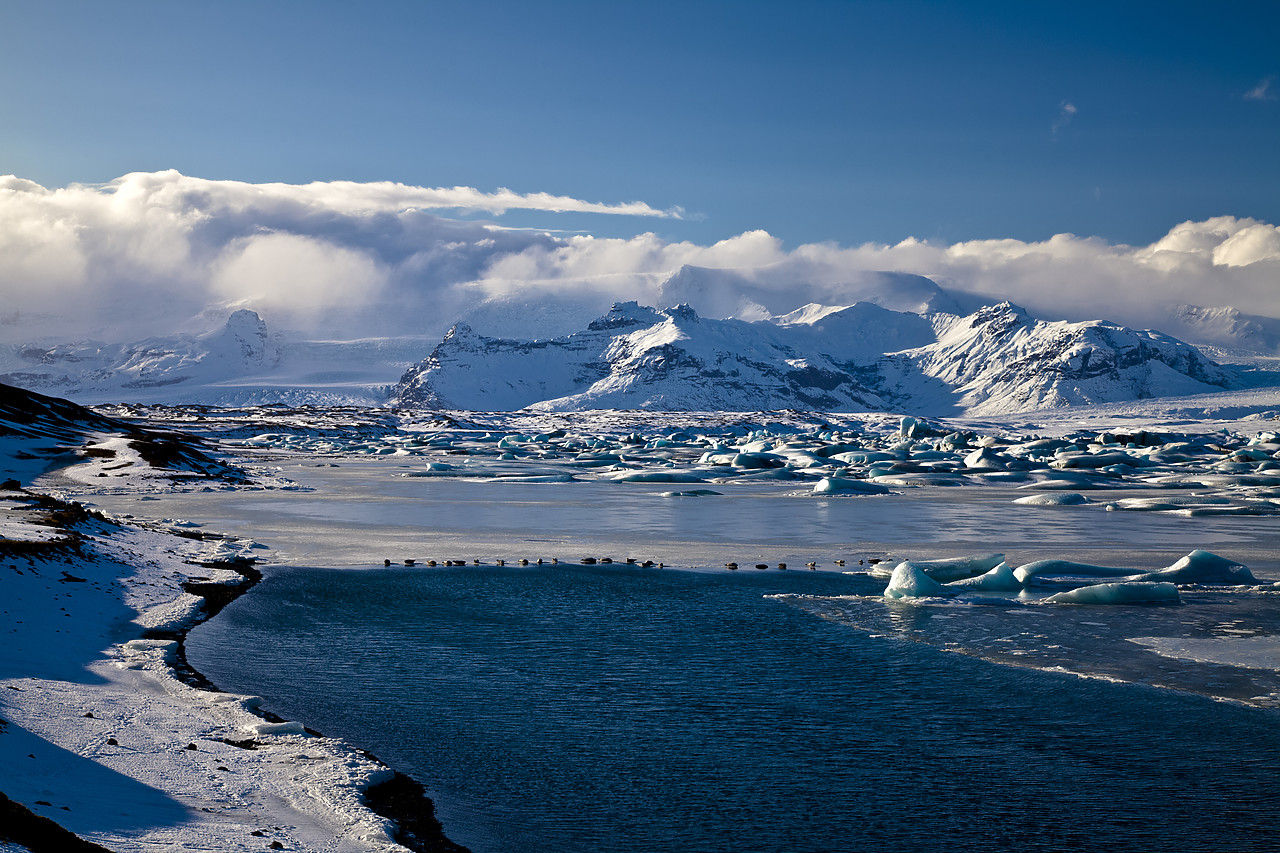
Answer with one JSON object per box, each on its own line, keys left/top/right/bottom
{"left": 0, "top": 0, "right": 1280, "bottom": 246}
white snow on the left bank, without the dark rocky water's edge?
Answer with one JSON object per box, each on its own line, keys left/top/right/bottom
{"left": 0, "top": 466, "right": 414, "bottom": 853}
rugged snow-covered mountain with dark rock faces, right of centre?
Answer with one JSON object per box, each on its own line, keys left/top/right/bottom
{"left": 392, "top": 302, "right": 1233, "bottom": 415}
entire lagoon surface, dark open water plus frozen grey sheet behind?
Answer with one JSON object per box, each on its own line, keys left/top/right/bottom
{"left": 147, "top": 465, "right": 1280, "bottom": 853}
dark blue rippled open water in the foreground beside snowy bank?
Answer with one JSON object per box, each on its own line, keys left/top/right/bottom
{"left": 188, "top": 565, "right": 1280, "bottom": 853}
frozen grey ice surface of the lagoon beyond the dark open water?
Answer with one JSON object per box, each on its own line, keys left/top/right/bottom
{"left": 96, "top": 460, "right": 1280, "bottom": 707}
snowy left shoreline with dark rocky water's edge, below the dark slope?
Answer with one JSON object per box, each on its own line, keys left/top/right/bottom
{"left": 0, "top": 487, "right": 467, "bottom": 853}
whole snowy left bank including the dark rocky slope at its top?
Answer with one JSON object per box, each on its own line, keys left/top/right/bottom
{"left": 0, "top": 381, "right": 460, "bottom": 853}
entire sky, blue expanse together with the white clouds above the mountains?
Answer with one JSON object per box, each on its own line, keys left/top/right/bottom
{"left": 0, "top": 0, "right": 1280, "bottom": 338}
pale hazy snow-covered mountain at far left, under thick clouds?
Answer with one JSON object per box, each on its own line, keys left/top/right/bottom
{"left": 0, "top": 310, "right": 431, "bottom": 405}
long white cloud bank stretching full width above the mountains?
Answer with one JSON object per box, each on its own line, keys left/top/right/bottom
{"left": 0, "top": 172, "right": 1280, "bottom": 341}
